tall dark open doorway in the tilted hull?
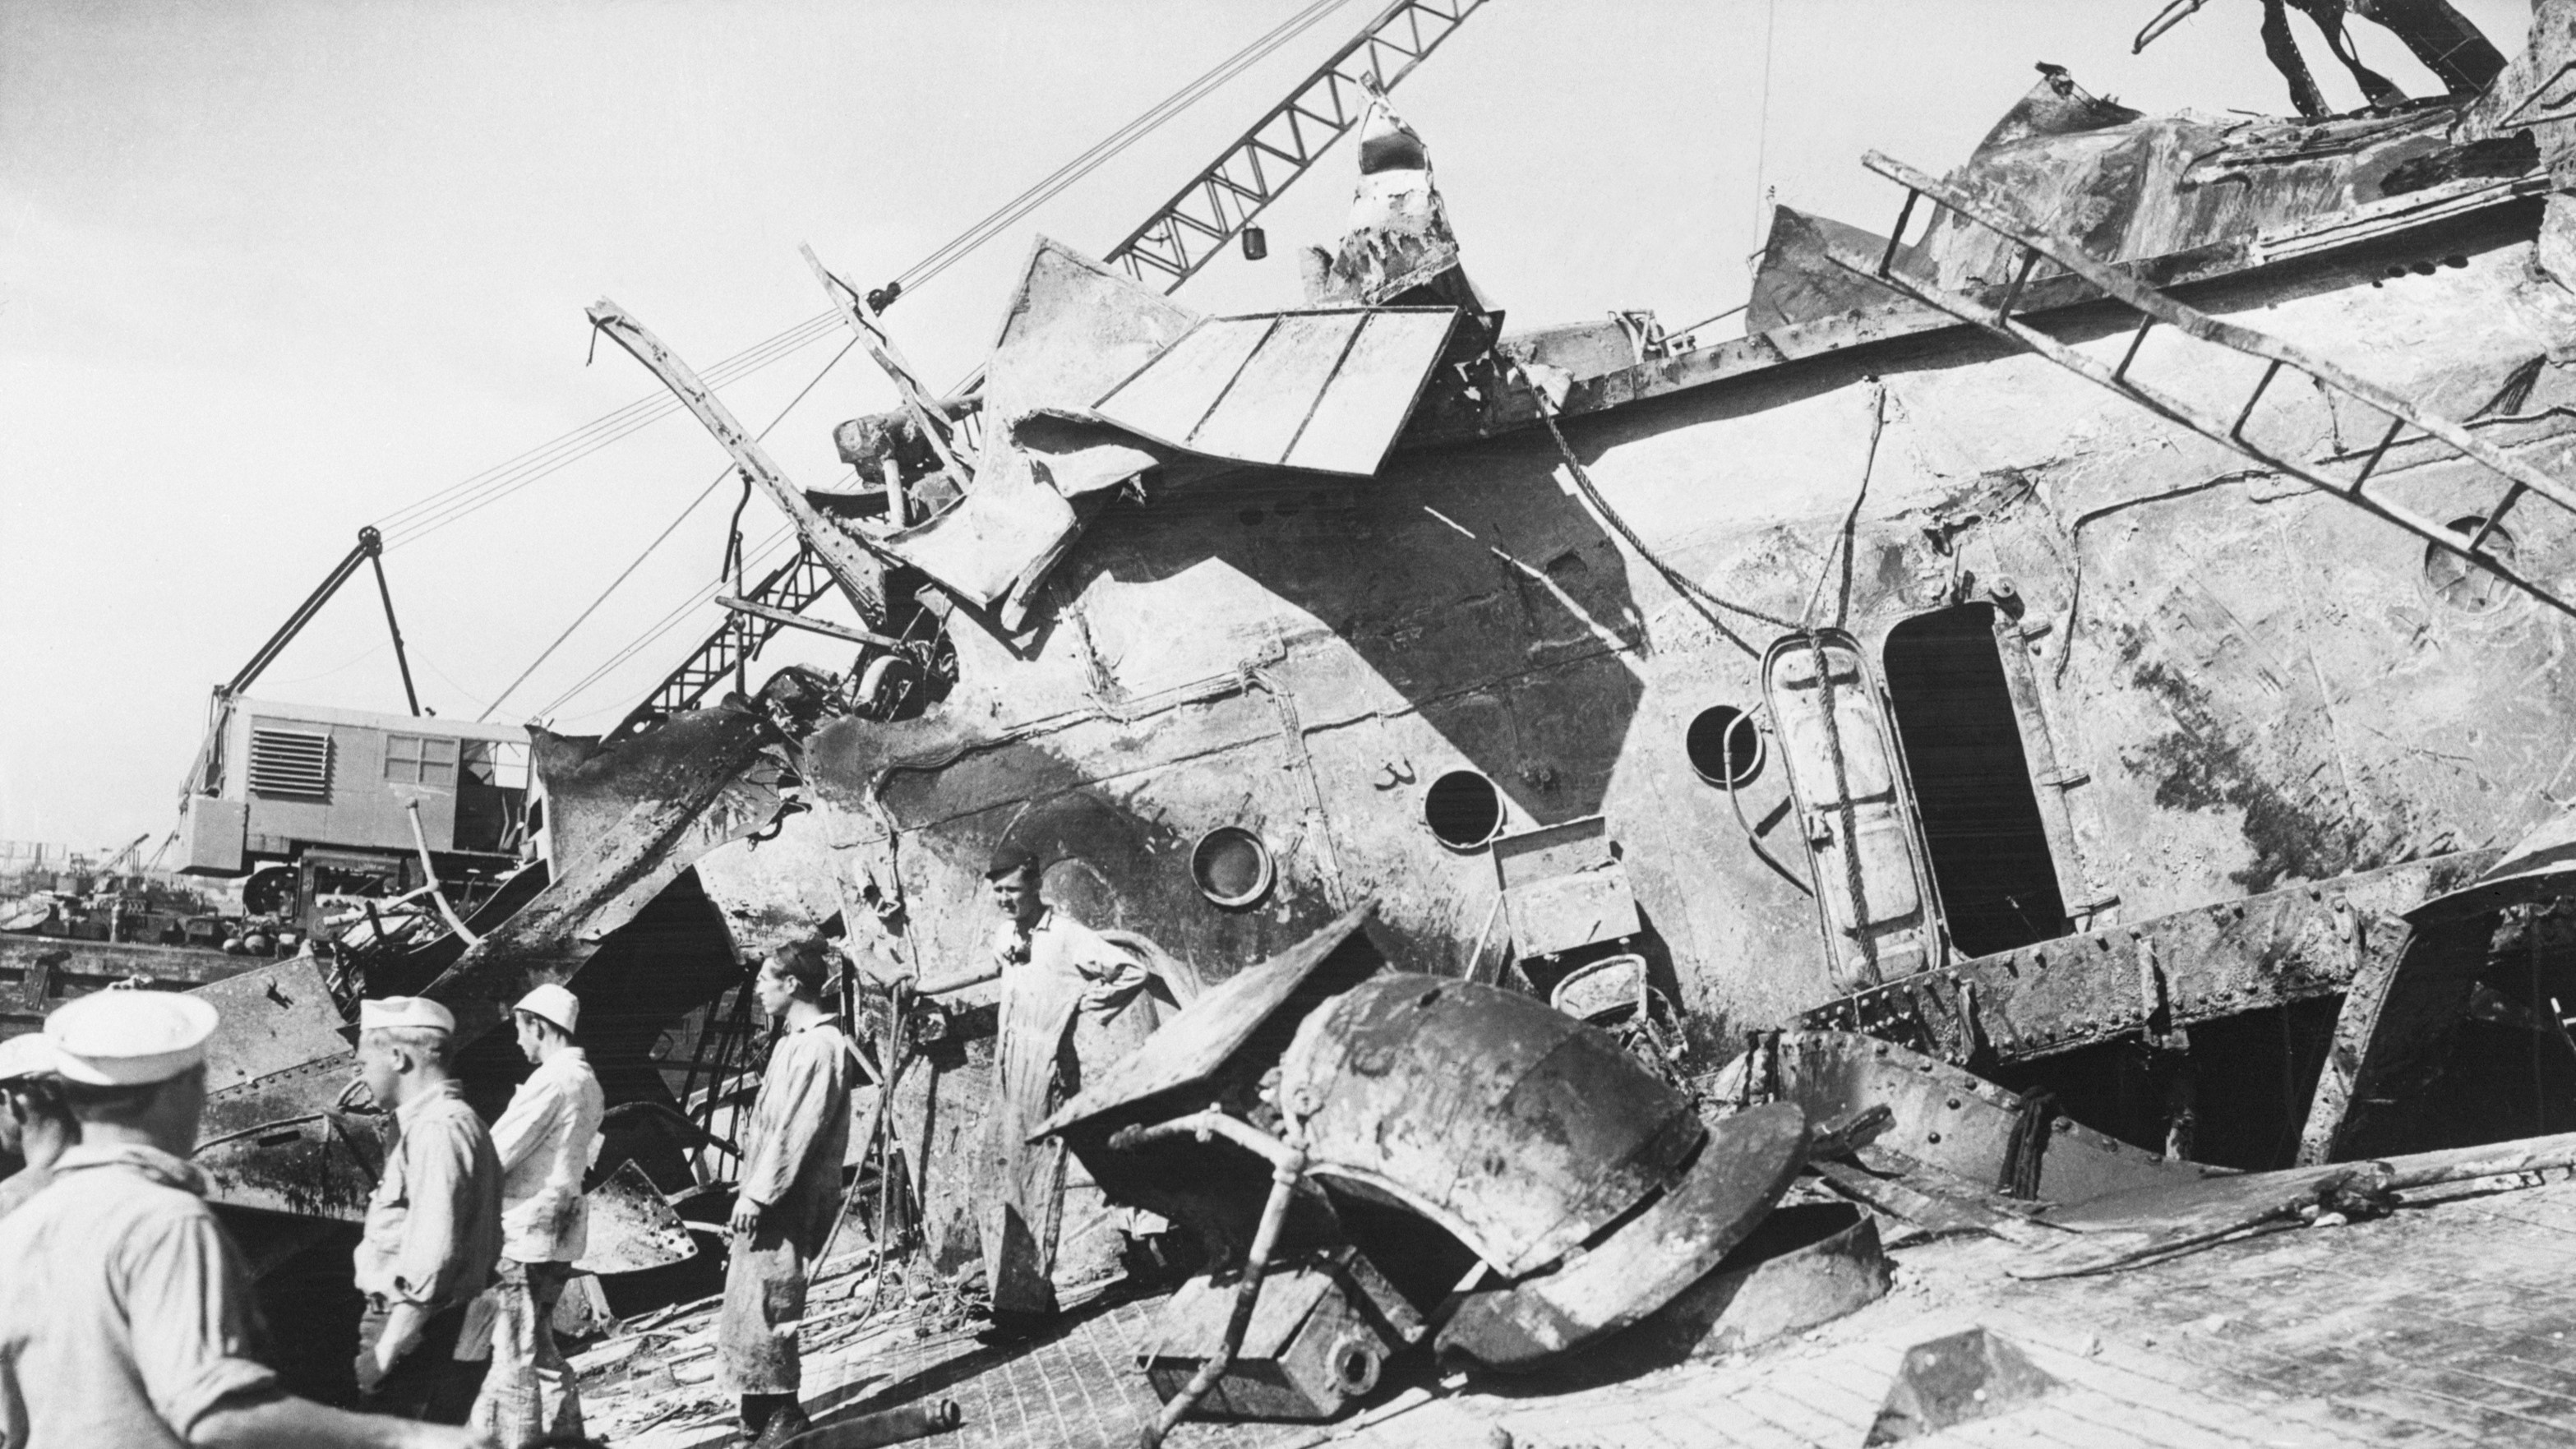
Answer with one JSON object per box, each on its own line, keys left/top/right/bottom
{"left": 1881, "top": 605, "right": 2069, "bottom": 955}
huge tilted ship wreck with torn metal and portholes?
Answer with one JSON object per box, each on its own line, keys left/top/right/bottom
{"left": 25, "top": 0, "right": 2576, "bottom": 1431}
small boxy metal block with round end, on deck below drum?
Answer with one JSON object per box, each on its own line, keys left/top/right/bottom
{"left": 1136, "top": 1246, "right": 1427, "bottom": 1421}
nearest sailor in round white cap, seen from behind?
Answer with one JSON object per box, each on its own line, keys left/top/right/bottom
{"left": 0, "top": 991, "right": 479, "bottom": 1449}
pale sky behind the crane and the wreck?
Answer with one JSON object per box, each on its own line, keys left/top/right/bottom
{"left": 0, "top": 0, "right": 2530, "bottom": 849}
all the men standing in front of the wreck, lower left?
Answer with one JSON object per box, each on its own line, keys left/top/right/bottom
{"left": 0, "top": 849, "right": 1154, "bottom": 1449}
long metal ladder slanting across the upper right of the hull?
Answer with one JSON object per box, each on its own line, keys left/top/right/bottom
{"left": 1829, "top": 152, "right": 2576, "bottom": 612}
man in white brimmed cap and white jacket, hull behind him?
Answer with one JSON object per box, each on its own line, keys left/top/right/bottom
{"left": 469, "top": 981, "right": 608, "bottom": 1449}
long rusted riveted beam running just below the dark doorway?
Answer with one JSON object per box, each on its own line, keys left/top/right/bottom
{"left": 1803, "top": 849, "right": 2496, "bottom": 1063}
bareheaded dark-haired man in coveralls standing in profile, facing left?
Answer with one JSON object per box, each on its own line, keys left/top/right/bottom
{"left": 716, "top": 942, "right": 858, "bottom": 1449}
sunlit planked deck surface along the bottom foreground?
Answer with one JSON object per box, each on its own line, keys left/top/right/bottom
{"left": 584, "top": 1181, "right": 2576, "bottom": 1449}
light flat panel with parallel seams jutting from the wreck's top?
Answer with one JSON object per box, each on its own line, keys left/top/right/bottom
{"left": 1092, "top": 307, "right": 1458, "bottom": 476}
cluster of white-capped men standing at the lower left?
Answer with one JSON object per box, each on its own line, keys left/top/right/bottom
{"left": 0, "top": 985, "right": 602, "bottom": 1449}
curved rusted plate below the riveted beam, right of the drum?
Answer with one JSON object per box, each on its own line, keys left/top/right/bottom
{"left": 1775, "top": 1032, "right": 2223, "bottom": 1202}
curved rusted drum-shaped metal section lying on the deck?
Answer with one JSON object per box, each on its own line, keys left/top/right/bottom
{"left": 1281, "top": 976, "right": 1700, "bottom": 1276}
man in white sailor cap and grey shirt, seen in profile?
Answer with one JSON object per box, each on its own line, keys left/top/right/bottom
{"left": 355, "top": 996, "right": 500, "bottom": 1424}
